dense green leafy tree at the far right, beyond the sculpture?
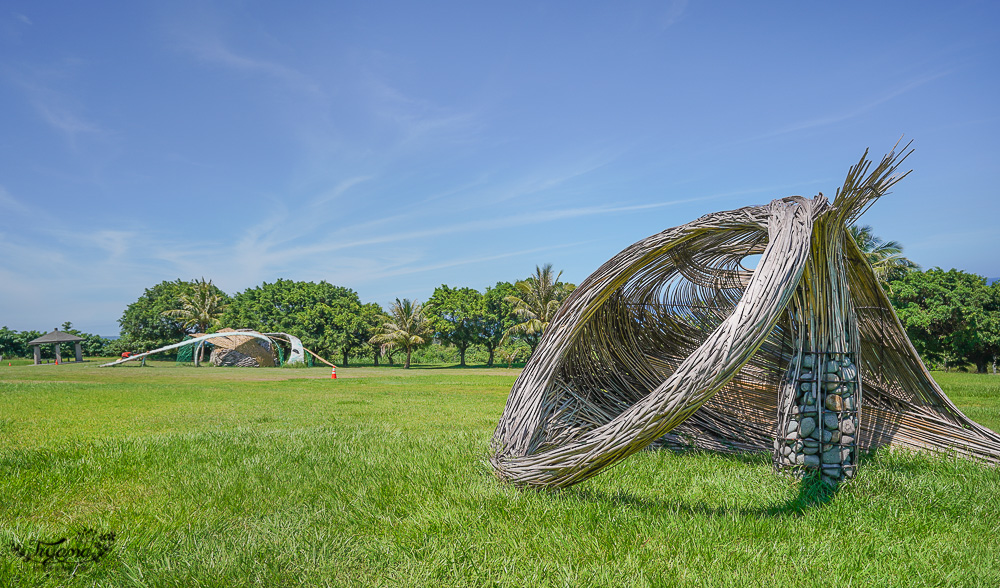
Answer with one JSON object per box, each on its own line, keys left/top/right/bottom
{"left": 890, "top": 268, "right": 1000, "bottom": 372}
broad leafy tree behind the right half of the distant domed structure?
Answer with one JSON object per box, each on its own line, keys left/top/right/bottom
{"left": 221, "top": 279, "right": 361, "bottom": 365}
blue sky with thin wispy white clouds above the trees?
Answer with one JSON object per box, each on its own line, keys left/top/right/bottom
{"left": 0, "top": 0, "right": 1000, "bottom": 335}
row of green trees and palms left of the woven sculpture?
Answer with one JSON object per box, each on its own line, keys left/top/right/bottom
{"left": 0, "top": 265, "right": 575, "bottom": 367}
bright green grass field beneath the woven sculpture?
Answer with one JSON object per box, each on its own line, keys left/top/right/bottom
{"left": 0, "top": 362, "right": 1000, "bottom": 588}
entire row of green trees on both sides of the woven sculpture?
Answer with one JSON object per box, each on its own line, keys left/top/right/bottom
{"left": 0, "top": 226, "right": 1000, "bottom": 373}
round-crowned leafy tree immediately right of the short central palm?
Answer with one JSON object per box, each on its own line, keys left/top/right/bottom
{"left": 425, "top": 284, "right": 483, "bottom": 367}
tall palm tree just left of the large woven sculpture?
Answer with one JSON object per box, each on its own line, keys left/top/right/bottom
{"left": 501, "top": 263, "right": 576, "bottom": 353}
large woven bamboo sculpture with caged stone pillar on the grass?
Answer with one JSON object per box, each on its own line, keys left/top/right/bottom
{"left": 491, "top": 149, "right": 1000, "bottom": 487}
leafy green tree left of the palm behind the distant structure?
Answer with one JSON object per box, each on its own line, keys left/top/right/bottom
{"left": 115, "top": 280, "right": 196, "bottom": 352}
